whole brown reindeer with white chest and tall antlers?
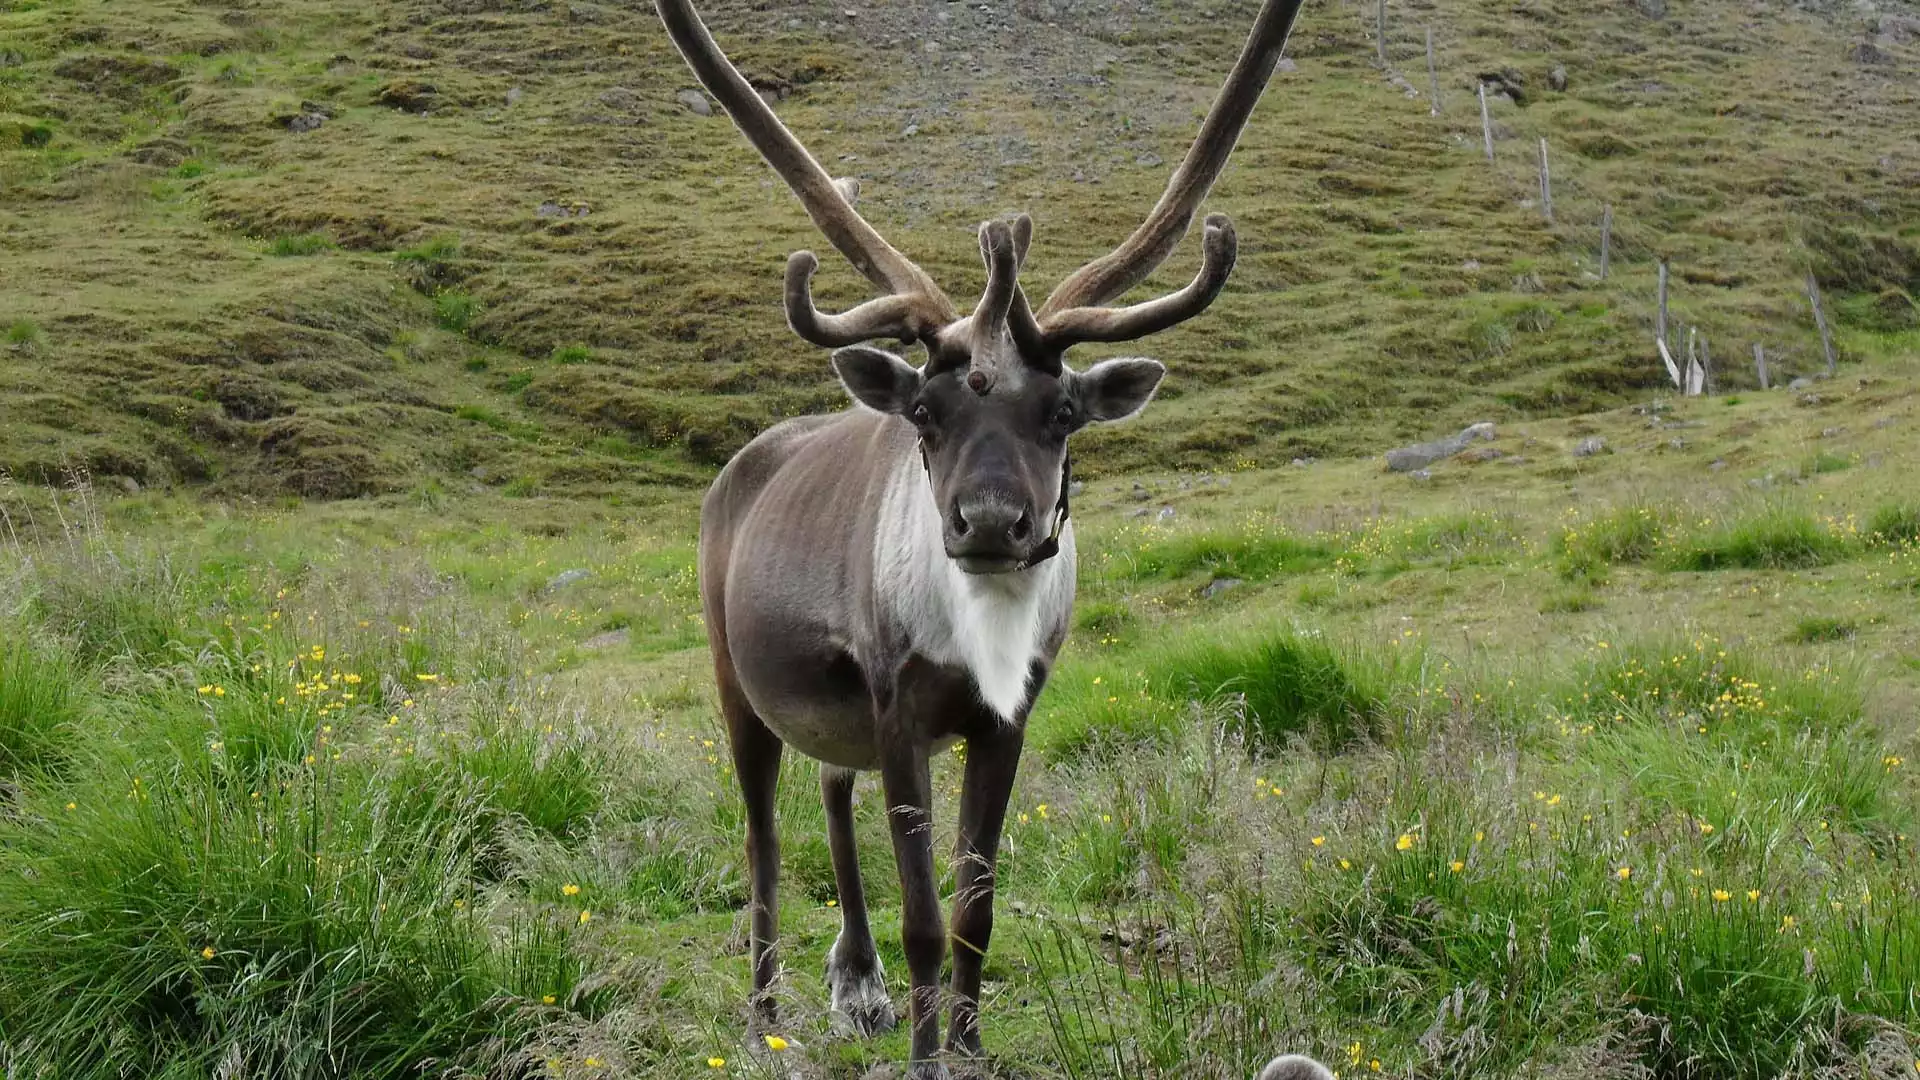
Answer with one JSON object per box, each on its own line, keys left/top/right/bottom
{"left": 657, "top": 0, "right": 1300, "bottom": 1080}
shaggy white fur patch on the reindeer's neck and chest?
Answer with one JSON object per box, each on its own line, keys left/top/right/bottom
{"left": 874, "top": 454, "right": 1073, "bottom": 723}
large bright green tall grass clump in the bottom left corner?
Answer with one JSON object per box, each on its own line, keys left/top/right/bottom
{"left": 0, "top": 730, "right": 586, "bottom": 1076}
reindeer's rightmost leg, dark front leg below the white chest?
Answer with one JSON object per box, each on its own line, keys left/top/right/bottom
{"left": 947, "top": 717, "right": 1025, "bottom": 1057}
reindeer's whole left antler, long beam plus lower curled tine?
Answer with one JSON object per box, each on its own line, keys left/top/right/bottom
{"left": 655, "top": 0, "right": 958, "bottom": 348}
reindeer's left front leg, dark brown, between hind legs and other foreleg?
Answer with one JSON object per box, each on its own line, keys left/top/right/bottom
{"left": 877, "top": 701, "right": 947, "bottom": 1080}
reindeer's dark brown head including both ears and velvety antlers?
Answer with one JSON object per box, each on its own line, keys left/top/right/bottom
{"left": 655, "top": 0, "right": 1300, "bottom": 573}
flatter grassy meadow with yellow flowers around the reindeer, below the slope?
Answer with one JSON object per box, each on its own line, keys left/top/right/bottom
{"left": 0, "top": 351, "right": 1920, "bottom": 1080}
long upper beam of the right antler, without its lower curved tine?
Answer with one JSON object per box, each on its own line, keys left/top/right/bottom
{"left": 1039, "top": 0, "right": 1302, "bottom": 319}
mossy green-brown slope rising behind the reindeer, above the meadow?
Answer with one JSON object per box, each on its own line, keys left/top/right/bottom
{"left": 0, "top": 0, "right": 1920, "bottom": 498}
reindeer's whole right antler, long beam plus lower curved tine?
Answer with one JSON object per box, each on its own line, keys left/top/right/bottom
{"left": 1014, "top": 0, "right": 1302, "bottom": 343}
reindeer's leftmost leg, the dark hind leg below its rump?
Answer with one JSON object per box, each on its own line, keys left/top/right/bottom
{"left": 714, "top": 661, "right": 783, "bottom": 1026}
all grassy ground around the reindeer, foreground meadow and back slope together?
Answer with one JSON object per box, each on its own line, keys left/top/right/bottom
{"left": 0, "top": 0, "right": 1920, "bottom": 1080}
